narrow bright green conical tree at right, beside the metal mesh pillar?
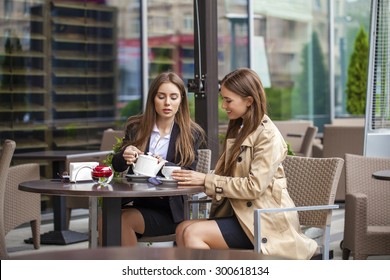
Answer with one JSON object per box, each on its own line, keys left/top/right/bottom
{"left": 346, "top": 27, "right": 369, "bottom": 115}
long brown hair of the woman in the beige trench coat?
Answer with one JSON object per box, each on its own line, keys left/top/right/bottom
{"left": 215, "top": 68, "right": 267, "bottom": 176}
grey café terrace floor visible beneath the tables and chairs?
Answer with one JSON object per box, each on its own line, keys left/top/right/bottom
{"left": 6, "top": 204, "right": 390, "bottom": 260}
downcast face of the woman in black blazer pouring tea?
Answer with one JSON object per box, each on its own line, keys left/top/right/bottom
{"left": 154, "top": 82, "right": 181, "bottom": 119}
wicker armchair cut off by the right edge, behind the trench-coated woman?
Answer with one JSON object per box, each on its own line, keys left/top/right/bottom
{"left": 341, "top": 154, "right": 390, "bottom": 260}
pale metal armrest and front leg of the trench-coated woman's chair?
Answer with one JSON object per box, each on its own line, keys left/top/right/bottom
{"left": 254, "top": 204, "right": 339, "bottom": 253}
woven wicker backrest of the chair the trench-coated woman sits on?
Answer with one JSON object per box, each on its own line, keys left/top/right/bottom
{"left": 282, "top": 156, "right": 344, "bottom": 228}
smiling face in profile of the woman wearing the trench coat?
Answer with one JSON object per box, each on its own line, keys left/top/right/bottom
{"left": 221, "top": 86, "right": 253, "bottom": 120}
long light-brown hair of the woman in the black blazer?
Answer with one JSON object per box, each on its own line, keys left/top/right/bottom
{"left": 122, "top": 72, "right": 205, "bottom": 166}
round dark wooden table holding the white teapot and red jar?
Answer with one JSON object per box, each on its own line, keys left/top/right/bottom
{"left": 19, "top": 178, "right": 204, "bottom": 247}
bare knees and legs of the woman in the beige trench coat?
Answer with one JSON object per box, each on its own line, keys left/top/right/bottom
{"left": 176, "top": 220, "right": 229, "bottom": 249}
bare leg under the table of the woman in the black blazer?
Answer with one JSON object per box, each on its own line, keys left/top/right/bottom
{"left": 121, "top": 208, "right": 145, "bottom": 246}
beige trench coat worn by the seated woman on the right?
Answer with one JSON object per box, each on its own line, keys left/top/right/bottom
{"left": 205, "top": 116, "right": 317, "bottom": 259}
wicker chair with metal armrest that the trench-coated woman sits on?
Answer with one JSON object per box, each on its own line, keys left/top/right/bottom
{"left": 254, "top": 156, "right": 344, "bottom": 259}
